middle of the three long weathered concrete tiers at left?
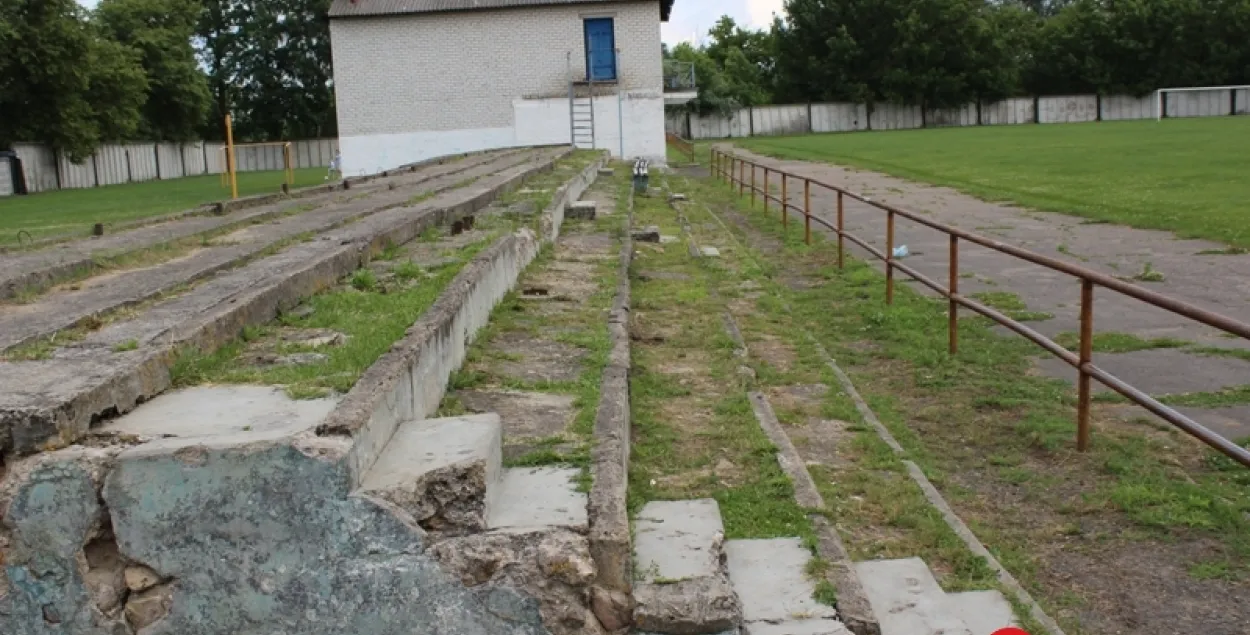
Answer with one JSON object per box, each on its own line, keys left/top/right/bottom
{"left": 0, "top": 148, "right": 547, "bottom": 351}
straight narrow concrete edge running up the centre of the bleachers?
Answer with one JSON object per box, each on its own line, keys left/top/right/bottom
{"left": 586, "top": 177, "right": 634, "bottom": 610}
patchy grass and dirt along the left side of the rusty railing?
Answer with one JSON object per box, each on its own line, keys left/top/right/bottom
{"left": 688, "top": 160, "right": 1250, "bottom": 635}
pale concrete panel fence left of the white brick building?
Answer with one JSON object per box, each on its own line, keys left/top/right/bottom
{"left": 7, "top": 139, "right": 339, "bottom": 196}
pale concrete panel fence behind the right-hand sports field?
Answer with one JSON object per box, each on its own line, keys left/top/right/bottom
{"left": 665, "top": 89, "right": 1250, "bottom": 140}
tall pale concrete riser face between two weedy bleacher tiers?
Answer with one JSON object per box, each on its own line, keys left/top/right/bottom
{"left": 310, "top": 150, "right": 603, "bottom": 486}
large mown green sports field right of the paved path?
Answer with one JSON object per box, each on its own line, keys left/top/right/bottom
{"left": 735, "top": 118, "right": 1250, "bottom": 248}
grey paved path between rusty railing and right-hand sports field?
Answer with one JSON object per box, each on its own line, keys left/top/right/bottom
{"left": 738, "top": 149, "right": 1250, "bottom": 439}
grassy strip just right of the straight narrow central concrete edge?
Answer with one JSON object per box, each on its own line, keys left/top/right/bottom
{"left": 629, "top": 176, "right": 813, "bottom": 539}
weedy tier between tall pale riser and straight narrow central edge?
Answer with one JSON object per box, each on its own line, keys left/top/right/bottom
{"left": 440, "top": 163, "right": 629, "bottom": 475}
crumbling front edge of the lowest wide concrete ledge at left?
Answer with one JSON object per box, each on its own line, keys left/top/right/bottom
{"left": 0, "top": 150, "right": 571, "bottom": 455}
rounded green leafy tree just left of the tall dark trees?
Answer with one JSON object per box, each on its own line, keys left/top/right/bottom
{"left": 95, "top": 0, "right": 210, "bottom": 141}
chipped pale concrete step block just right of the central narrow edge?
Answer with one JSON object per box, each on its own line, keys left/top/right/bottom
{"left": 634, "top": 499, "right": 743, "bottom": 635}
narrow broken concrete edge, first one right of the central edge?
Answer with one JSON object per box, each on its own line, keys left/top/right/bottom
{"left": 726, "top": 390, "right": 881, "bottom": 635}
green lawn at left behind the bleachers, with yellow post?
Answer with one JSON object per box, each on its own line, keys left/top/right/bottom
{"left": 0, "top": 168, "right": 325, "bottom": 245}
